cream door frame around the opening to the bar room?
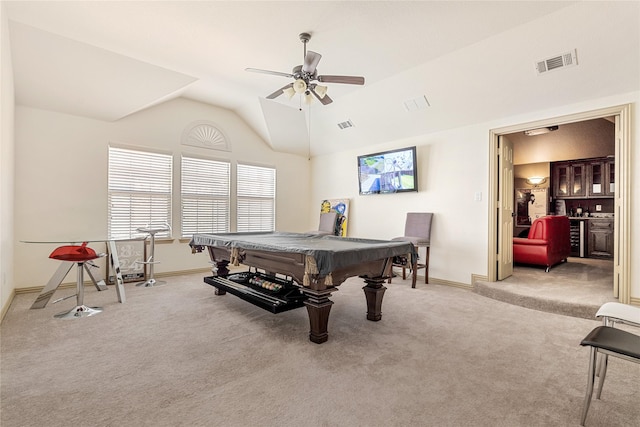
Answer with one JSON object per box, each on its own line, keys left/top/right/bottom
{"left": 487, "top": 104, "right": 632, "bottom": 304}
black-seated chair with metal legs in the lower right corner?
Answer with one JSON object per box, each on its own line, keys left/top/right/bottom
{"left": 580, "top": 326, "right": 640, "bottom": 426}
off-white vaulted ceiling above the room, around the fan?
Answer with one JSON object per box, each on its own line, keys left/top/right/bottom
{"left": 3, "top": 1, "right": 640, "bottom": 155}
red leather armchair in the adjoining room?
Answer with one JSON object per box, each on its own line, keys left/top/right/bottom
{"left": 513, "top": 216, "right": 571, "bottom": 272}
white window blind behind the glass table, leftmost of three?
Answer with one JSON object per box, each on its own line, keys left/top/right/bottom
{"left": 108, "top": 147, "right": 173, "bottom": 239}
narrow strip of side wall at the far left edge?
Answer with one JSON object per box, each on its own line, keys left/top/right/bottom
{"left": 0, "top": 3, "right": 15, "bottom": 319}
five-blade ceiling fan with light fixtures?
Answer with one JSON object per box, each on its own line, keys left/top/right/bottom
{"left": 245, "top": 33, "right": 364, "bottom": 105}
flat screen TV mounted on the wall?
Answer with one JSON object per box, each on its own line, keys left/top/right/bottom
{"left": 358, "top": 147, "right": 418, "bottom": 194}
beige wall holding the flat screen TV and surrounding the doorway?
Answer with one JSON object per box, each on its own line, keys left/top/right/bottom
{"left": 311, "top": 92, "right": 640, "bottom": 299}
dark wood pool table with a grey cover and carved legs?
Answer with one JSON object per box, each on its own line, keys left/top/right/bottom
{"left": 189, "top": 232, "right": 417, "bottom": 344}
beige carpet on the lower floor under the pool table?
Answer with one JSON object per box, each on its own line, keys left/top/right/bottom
{"left": 0, "top": 275, "right": 640, "bottom": 427}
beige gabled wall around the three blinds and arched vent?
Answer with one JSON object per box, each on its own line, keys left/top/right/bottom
{"left": 10, "top": 98, "right": 311, "bottom": 288}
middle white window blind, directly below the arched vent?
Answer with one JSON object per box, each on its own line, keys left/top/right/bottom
{"left": 180, "top": 156, "right": 231, "bottom": 238}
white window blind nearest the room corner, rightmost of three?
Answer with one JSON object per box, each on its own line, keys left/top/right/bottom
{"left": 236, "top": 164, "right": 276, "bottom": 232}
